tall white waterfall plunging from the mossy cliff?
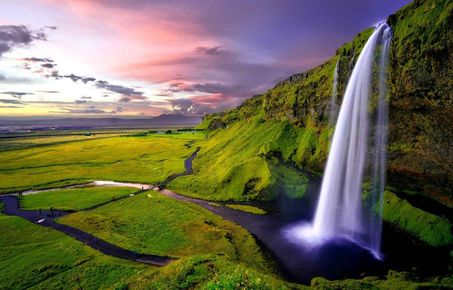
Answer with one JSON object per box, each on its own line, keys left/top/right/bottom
{"left": 285, "top": 23, "right": 391, "bottom": 259}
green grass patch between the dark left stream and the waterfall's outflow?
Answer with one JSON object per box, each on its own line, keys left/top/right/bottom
{"left": 58, "top": 192, "right": 267, "bottom": 267}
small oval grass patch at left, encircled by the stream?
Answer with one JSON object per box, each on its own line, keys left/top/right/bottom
{"left": 20, "top": 187, "right": 138, "bottom": 210}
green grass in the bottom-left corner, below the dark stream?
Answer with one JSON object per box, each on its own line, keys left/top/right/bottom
{"left": 0, "top": 214, "right": 147, "bottom": 289}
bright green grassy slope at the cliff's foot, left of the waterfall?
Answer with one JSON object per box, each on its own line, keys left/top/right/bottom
{"left": 168, "top": 119, "right": 310, "bottom": 200}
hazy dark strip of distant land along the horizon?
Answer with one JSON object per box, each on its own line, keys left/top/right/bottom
{"left": 0, "top": 114, "right": 201, "bottom": 131}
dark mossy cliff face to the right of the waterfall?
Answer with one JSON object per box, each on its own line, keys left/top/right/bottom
{"left": 388, "top": 0, "right": 453, "bottom": 205}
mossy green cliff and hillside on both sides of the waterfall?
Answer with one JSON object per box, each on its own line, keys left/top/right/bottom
{"left": 170, "top": 0, "right": 453, "bottom": 206}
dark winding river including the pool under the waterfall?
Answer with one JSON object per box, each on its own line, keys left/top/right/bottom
{"left": 0, "top": 148, "right": 448, "bottom": 283}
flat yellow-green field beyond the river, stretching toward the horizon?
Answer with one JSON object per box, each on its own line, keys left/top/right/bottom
{"left": 0, "top": 132, "right": 205, "bottom": 193}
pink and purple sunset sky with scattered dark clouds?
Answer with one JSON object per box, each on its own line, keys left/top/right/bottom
{"left": 0, "top": 0, "right": 410, "bottom": 117}
